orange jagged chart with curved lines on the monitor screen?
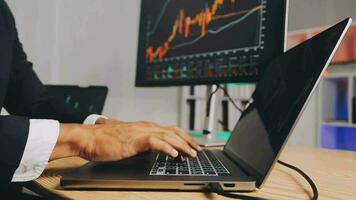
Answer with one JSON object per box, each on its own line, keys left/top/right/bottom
{"left": 146, "top": 0, "right": 263, "bottom": 62}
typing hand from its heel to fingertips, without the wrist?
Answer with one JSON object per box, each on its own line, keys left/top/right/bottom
{"left": 80, "top": 119, "right": 201, "bottom": 161}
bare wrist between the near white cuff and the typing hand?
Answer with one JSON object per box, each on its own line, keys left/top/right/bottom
{"left": 49, "top": 124, "right": 93, "bottom": 161}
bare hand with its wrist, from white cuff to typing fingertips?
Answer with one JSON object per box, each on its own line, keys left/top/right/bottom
{"left": 51, "top": 119, "right": 201, "bottom": 161}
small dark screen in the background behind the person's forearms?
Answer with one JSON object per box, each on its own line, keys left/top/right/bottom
{"left": 46, "top": 85, "right": 108, "bottom": 123}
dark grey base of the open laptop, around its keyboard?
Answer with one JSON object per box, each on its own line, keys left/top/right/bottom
{"left": 60, "top": 150, "right": 256, "bottom": 191}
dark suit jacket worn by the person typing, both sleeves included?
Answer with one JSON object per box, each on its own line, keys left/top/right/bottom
{"left": 0, "top": 0, "right": 86, "bottom": 189}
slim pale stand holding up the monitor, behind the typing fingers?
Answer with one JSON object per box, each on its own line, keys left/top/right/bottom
{"left": 195, "top": 85, "right": 227, "bottom": 147}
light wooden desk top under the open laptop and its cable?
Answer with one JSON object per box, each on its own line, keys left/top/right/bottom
{"left": 29, "top": 147, "right": 356, "bottom": 200}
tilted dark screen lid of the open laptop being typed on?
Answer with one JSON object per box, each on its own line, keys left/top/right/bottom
{"left": 224, "top": 19, "right": 351, "bottom": 187}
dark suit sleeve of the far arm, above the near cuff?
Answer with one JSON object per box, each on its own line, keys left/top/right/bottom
{"left": 4, "top": 0, "right": 87, "bottom": 123}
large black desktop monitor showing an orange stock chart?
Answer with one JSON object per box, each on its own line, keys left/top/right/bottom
{"left": 136, "top": 0, "right": 288, "bottom": 87}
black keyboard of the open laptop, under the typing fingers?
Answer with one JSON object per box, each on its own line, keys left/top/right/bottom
{"left": 150, "top": 151, "right": 230, "bottom": 176}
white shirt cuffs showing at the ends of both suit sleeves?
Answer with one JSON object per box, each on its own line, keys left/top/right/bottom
{"left": 12, "top": 115, "right": 106, "bottom": 182}
